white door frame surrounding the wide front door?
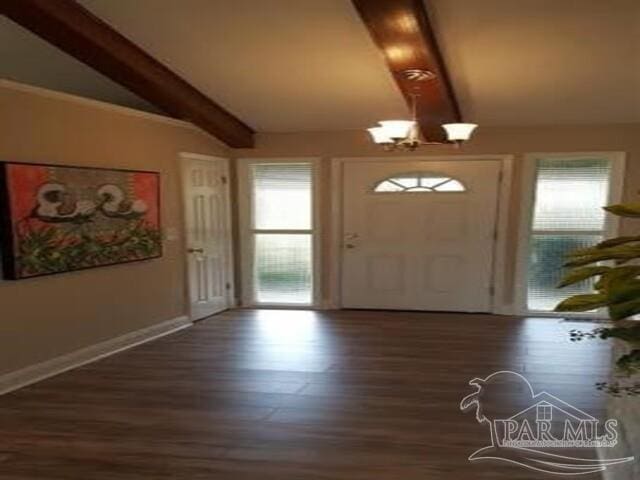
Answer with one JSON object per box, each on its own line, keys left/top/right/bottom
{"left": 330, "top": 154, "right": 515, "bottom": 315}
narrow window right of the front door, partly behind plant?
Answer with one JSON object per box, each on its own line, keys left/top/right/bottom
{"left": 527, "top": 159, "right": 611, "bottom": 311}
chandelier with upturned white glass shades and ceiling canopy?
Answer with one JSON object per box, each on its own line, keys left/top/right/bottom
{"left": 367, "top": 69, "right": 478, "bottom": 151}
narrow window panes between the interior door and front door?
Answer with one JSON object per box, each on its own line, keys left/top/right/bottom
{"left": 251, "top": 163, "right": 313, "bottom": 305}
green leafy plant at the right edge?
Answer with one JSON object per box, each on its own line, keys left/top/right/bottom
{"left": 555, "top": 204, "right": 640, "bottom": 396}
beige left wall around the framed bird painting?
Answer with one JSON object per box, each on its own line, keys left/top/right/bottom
{"left": 0, "top": 83, "right": 228, "bottom": 373}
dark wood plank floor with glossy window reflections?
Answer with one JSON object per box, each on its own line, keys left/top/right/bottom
{"left": 0, "top": 310, "right": 609, "bottom": 480}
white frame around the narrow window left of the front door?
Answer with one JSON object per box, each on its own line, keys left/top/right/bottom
{"left": 236, "top": 157, "right": 323, "bottom": 309}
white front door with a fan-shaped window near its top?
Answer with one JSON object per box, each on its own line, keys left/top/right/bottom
{"left": 342, "top": 161, "right": 501, "bottom": 312}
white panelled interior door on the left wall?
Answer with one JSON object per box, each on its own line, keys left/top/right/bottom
{"left": 182, "top": 155, "right": 233, "bottom": 320}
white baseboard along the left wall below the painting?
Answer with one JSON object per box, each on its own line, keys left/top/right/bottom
{"left": 0, "top": 316, "right": 193, "bottom": 395}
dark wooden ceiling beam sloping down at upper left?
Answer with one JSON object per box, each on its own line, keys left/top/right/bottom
{"left": 0, "top": 0, "right": 254, "bottom": 148}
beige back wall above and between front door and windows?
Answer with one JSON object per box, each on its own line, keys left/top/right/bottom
{"left": 234, "top": 125, "right": 640, "bottom": 305}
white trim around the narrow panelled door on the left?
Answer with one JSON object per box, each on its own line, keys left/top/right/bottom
{"left": 178, "top": 152, "right": 237, "bottom": 321}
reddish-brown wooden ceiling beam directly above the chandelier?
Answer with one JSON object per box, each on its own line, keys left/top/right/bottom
{"left": 352, "top": 0, "right": 462, "bottom": 142}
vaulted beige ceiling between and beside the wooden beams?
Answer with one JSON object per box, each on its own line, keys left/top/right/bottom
{"left": 0, "top": 0, "right": 640, "bottom": 132}
